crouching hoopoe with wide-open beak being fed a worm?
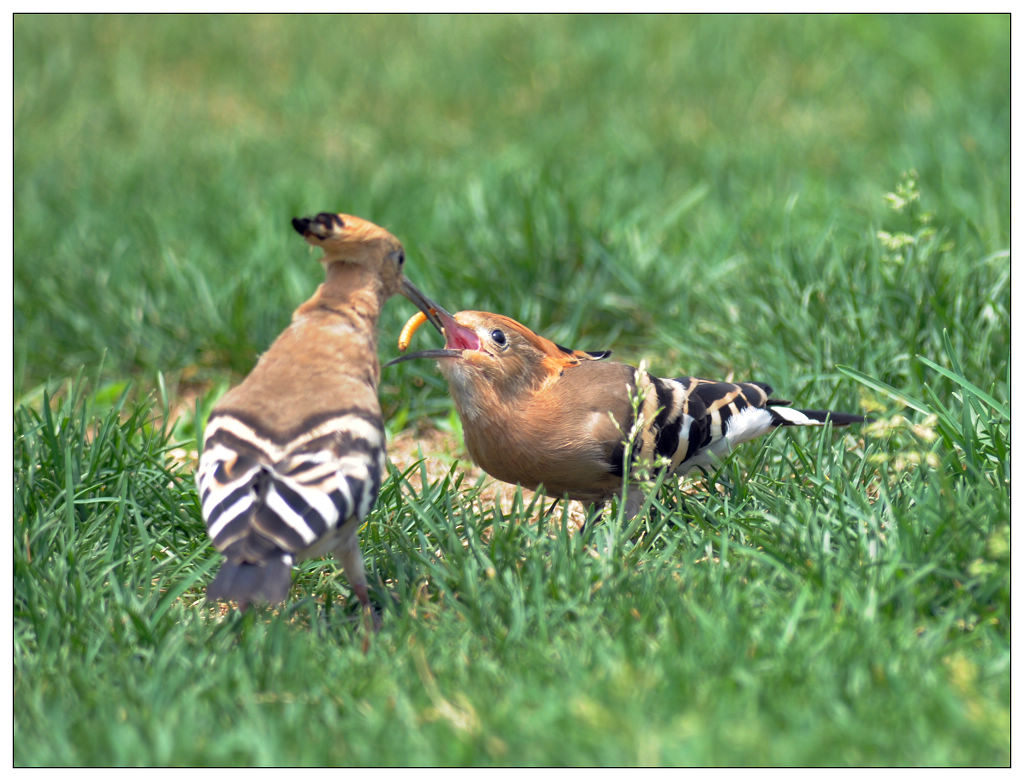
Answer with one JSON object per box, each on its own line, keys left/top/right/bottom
{"left": 386, "top": 307, "right": 864, "bottom": 518}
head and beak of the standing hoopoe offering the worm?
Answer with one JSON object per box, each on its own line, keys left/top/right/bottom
{"left": 292, "top": 212, "right": 441, "bottom": 331}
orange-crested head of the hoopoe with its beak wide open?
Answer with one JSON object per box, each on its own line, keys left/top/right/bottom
{"left": 388, "top": 309, "right": 611, "bottom": 411}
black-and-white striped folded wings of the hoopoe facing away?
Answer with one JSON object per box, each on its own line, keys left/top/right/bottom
{"left": 197, "top": 410, "right": 384, "bottom": 563}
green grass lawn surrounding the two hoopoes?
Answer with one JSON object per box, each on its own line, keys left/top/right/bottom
{"left": 13, "top": 15, "right": 1010, "bottom": 766}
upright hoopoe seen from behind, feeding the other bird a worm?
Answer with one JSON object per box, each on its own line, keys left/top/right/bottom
{"left": 196, "top": 212, "right": 439, "bottom": 610}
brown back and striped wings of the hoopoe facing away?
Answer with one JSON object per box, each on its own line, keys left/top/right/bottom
{"left": 197, "top": 305, "right": 384, "bottom": 602}
